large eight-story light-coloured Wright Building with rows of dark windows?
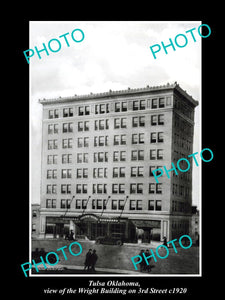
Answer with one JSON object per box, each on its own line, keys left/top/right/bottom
{"left": 40, "top": 82, "right": 198, "bottom": 241}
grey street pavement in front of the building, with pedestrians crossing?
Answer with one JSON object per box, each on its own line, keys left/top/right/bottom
{"left": 32, "top": 239, "right": 199, "bottom": 275}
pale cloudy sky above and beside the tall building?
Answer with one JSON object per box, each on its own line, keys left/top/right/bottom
{"left": 29, "top": 21, "right": 202, "bottom": 205}
